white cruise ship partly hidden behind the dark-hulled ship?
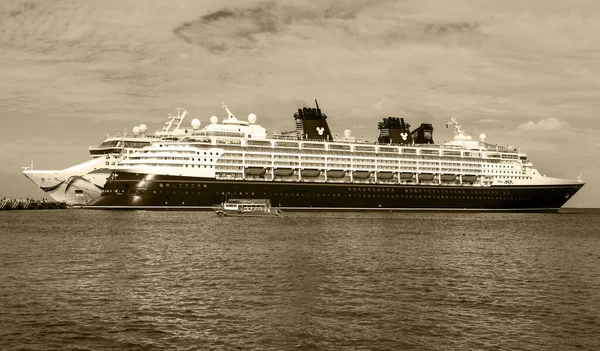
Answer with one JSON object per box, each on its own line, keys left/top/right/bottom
{"left": 23, "top": 108, "right": 192, "bottom": 206}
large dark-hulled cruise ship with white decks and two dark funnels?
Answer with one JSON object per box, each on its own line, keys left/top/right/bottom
{"left": 87, "top": 101, "right": 584, "bottom": 212}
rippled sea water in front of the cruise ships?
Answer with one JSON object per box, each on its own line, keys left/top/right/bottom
{"left": 0, "top": 209, "right": 600, "bottom": 350}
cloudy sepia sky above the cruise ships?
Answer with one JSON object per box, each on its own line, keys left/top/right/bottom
{"left": 0, "top": 0, "right": 600, "bottom": 207}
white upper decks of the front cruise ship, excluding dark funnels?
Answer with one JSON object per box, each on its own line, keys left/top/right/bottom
{"left": 117, "top": 104, "right": 580, "bottom": 186}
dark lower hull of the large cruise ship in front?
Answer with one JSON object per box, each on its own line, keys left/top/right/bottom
{"left": 87, "top": 172, "right": 583, "bottom": 212}
